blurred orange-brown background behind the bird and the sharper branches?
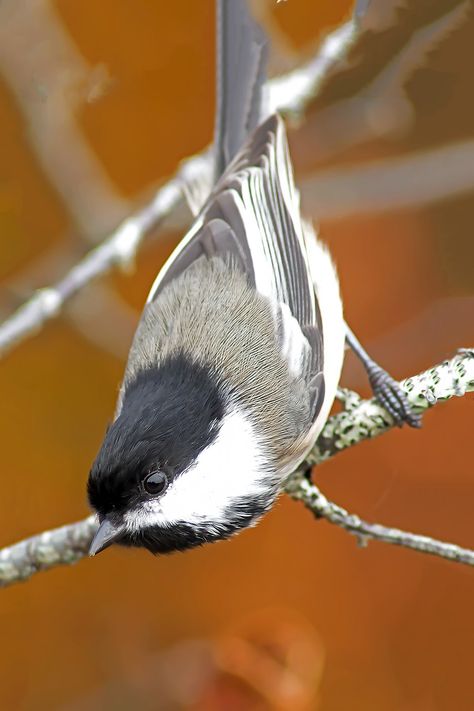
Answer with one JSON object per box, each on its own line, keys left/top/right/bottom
{"left": 0, "top": 0, "right": 474, "bottom": 711}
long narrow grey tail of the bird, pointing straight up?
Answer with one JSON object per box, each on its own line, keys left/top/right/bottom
{"left": 214, "top": 0, "right": 267, "bottom": 180}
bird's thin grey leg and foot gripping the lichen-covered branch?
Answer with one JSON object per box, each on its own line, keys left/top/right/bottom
{"left": 346, "top": 324, "right": 421, "bottom": 427}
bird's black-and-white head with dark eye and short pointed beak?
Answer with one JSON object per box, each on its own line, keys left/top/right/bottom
{"left": 88, "top": 355, "right": 278, "bottom": 555}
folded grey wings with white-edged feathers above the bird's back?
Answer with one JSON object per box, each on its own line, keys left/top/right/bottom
{"left": 148, "top": 115, "right": 324, "bottom": 415}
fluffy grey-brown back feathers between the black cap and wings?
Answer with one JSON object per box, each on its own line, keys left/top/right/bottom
{"left": 118, "top": 257, "right": 309, "bottom": 460}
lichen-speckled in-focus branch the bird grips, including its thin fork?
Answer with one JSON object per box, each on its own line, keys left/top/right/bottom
{"left": 0, "top": 349, "right": 474, "bottom": 587}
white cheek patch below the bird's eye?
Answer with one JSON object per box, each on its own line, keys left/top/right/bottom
{"left": 124, "top": 410, "right": 271, "bottom": 531}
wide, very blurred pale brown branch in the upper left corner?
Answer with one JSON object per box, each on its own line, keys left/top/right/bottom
{"left": 0, "top": 0, "right": 130, "bottom": 238}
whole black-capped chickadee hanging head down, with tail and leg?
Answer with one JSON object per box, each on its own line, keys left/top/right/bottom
{"left": 87, "top": 0, "right": 416, "bottom": 555}
